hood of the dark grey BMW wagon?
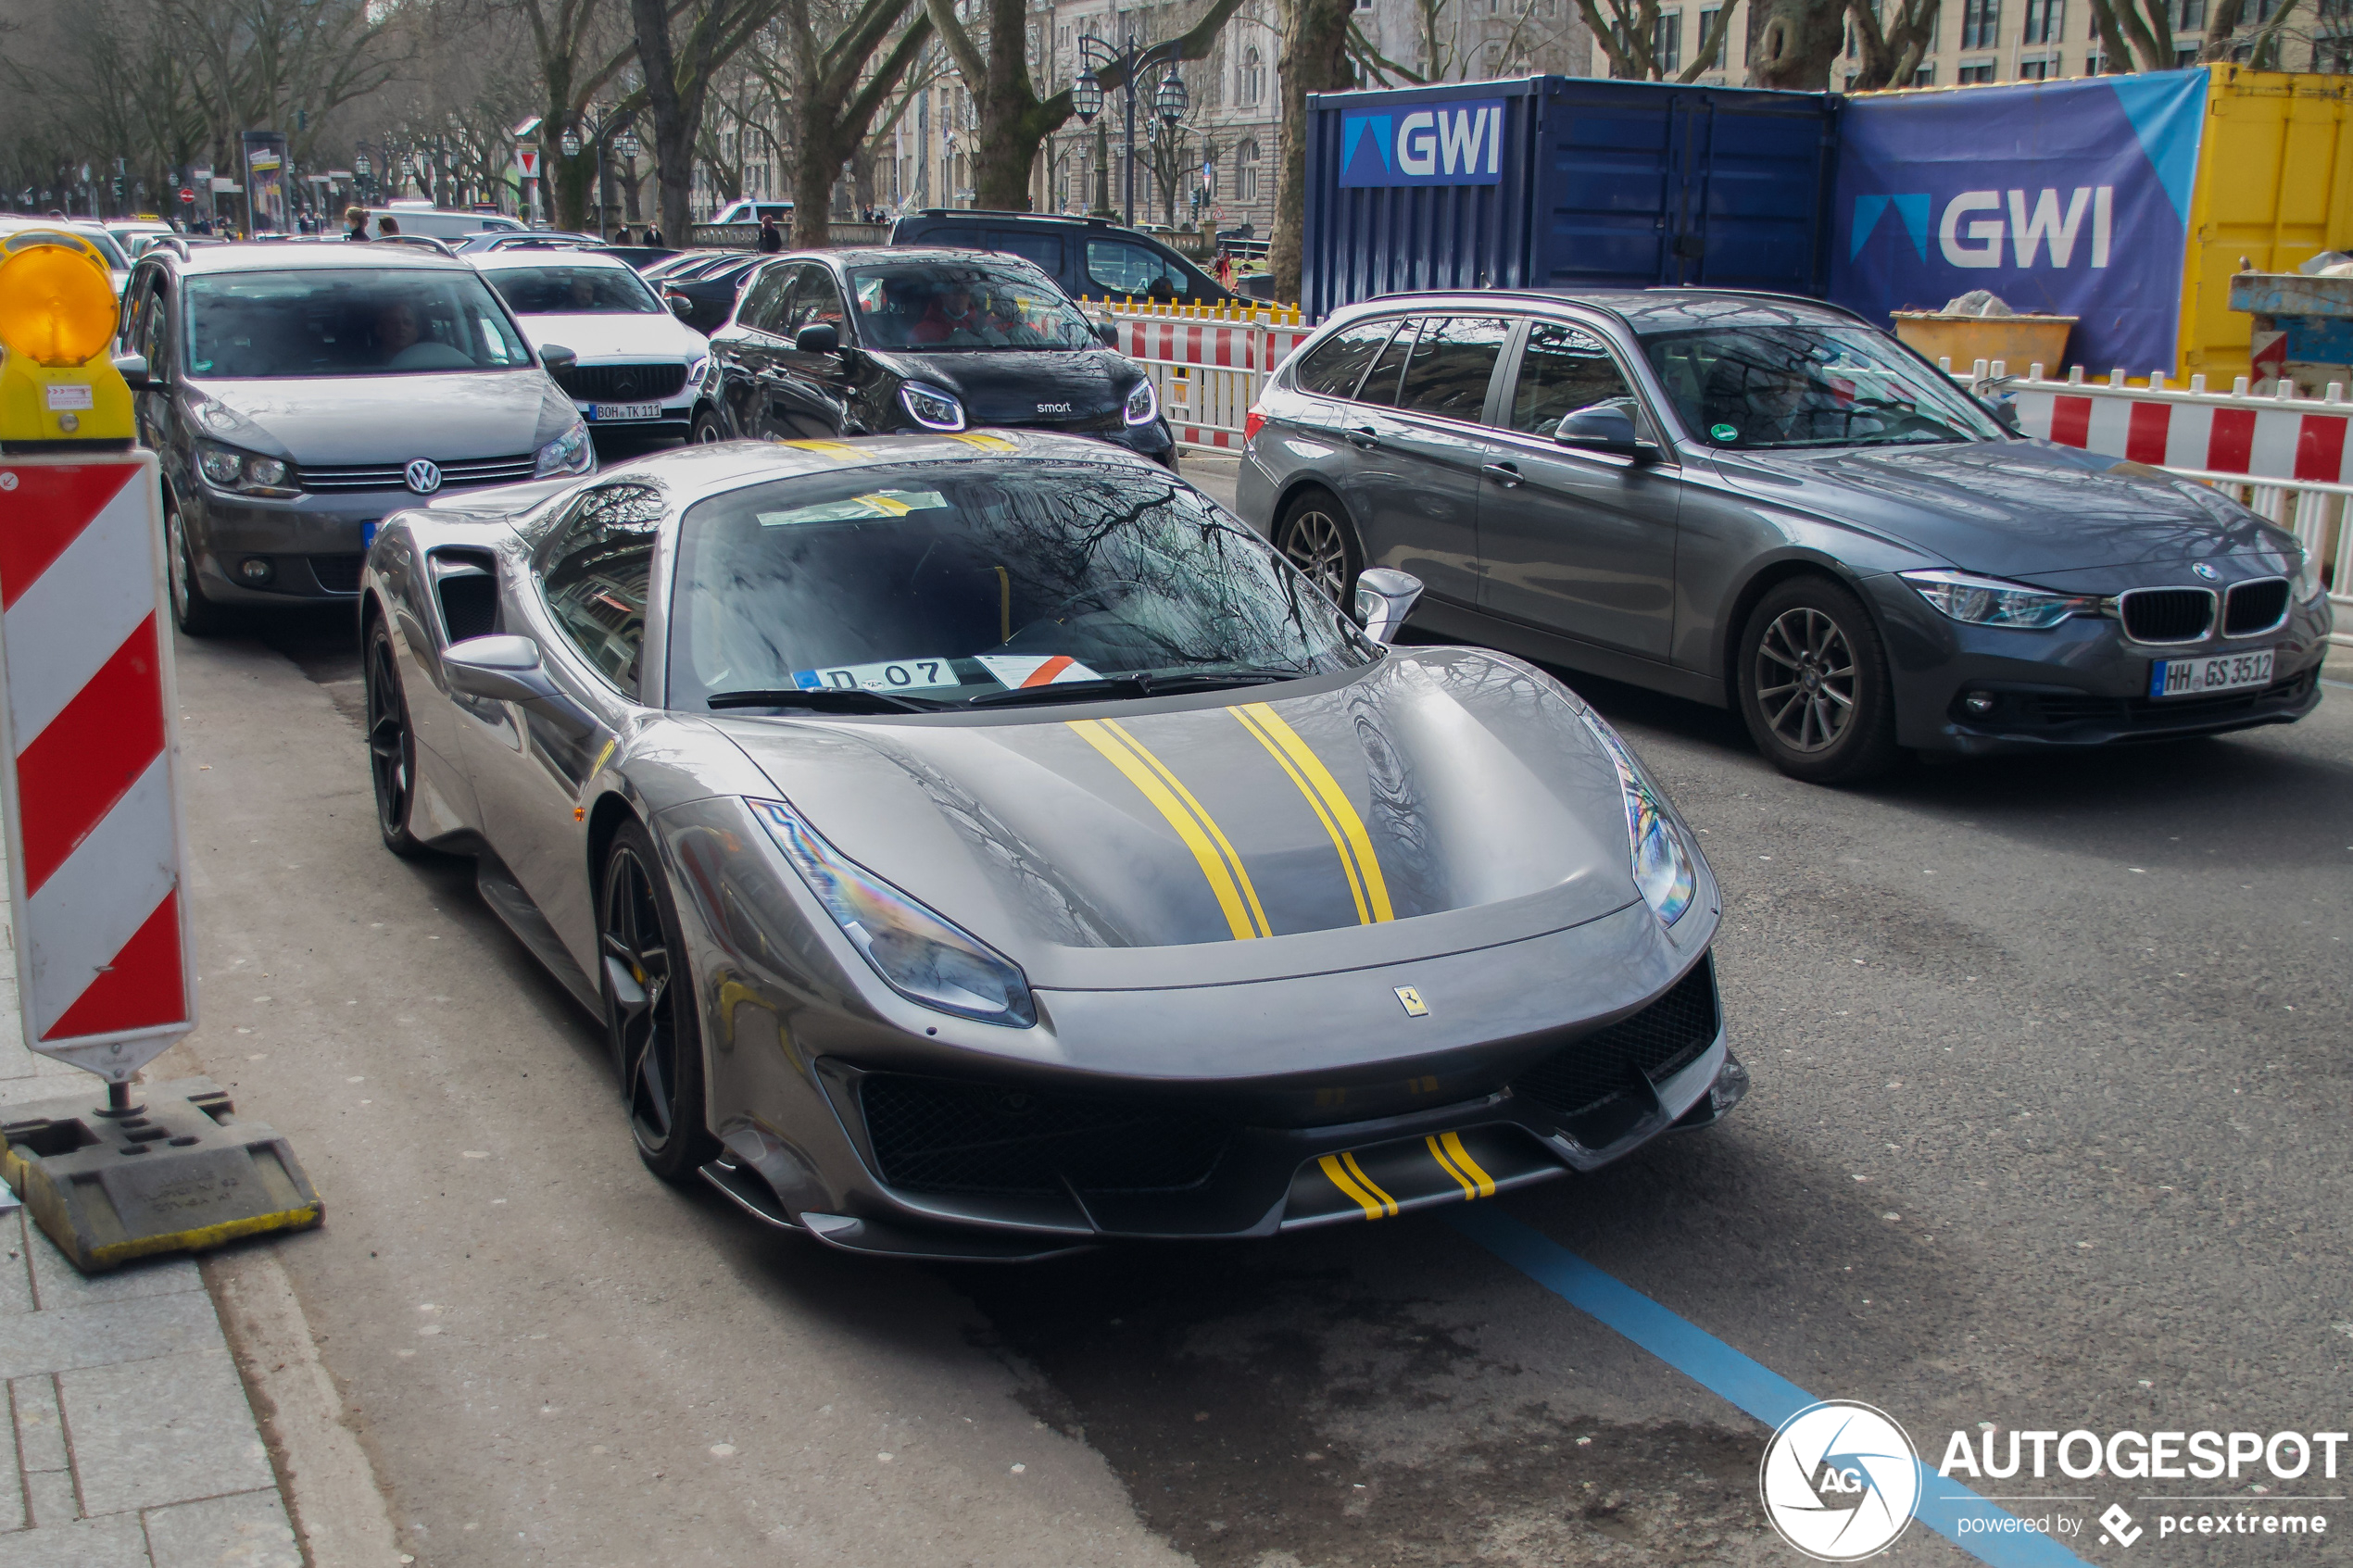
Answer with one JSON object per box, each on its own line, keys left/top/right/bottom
{"left": 1716, "top": 442, "right": 2283, "bottom": 578}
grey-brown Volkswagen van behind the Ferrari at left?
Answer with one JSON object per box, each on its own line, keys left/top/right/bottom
{"left": 118, "top": 240, "right": 596, "bottom": 634}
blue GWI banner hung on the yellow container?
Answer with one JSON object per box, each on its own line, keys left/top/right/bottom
{"left": 1831, "top": 70, "right": 2208, "bottom": 376}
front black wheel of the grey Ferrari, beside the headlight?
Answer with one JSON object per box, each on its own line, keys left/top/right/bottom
{"left": 598, "top": 822, "right": 718, "bottom": 1183}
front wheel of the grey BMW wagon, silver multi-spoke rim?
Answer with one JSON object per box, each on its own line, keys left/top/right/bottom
{"left": 1739, "top": 576, "right": 1896, "bottom": 783}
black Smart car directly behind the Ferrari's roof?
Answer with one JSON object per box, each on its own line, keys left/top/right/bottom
{"left": 694, "top": 249, "right": 1176, "bottom": 468}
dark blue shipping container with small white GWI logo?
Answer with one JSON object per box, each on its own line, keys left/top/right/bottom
{"left": 1299, "top": 75, "right": 1844, "bottom": 320}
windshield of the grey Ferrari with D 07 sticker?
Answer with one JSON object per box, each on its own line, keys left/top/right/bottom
{"left": 668, "top": 458, "right": 1372, "bottom": 708}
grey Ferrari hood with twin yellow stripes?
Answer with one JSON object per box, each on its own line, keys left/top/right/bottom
{"left": 713, "top": 649, "right": 1666, "bottom": 985}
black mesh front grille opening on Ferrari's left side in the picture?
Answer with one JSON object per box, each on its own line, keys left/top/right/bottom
{"left": 859, "top": 1072, "right": 1230, "bottom": 1194}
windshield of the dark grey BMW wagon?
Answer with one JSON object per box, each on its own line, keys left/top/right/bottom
{"left": 1642, "top": 327, "right": 2003, "bottom": 449}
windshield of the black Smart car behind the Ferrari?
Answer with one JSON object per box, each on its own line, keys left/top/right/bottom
{"left": 849, "top": 257, "right": 1101, "bottom": 353}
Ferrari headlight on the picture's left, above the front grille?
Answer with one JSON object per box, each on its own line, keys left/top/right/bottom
{"left": 746, "top": 799, "right": 1038, "bottom": 1027}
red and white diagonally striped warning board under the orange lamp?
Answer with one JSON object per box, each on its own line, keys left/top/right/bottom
{"left": 0, "top": 451, "right": 195, "bottom": 1082}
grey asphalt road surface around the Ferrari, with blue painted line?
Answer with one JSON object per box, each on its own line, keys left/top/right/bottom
{"left": 156, "top": 446, "right": 2353, "bottom": 1568}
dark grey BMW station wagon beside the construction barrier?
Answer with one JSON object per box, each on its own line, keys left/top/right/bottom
{"left": 1238, "top": 289, "right": 2330, "bottom": 783}
